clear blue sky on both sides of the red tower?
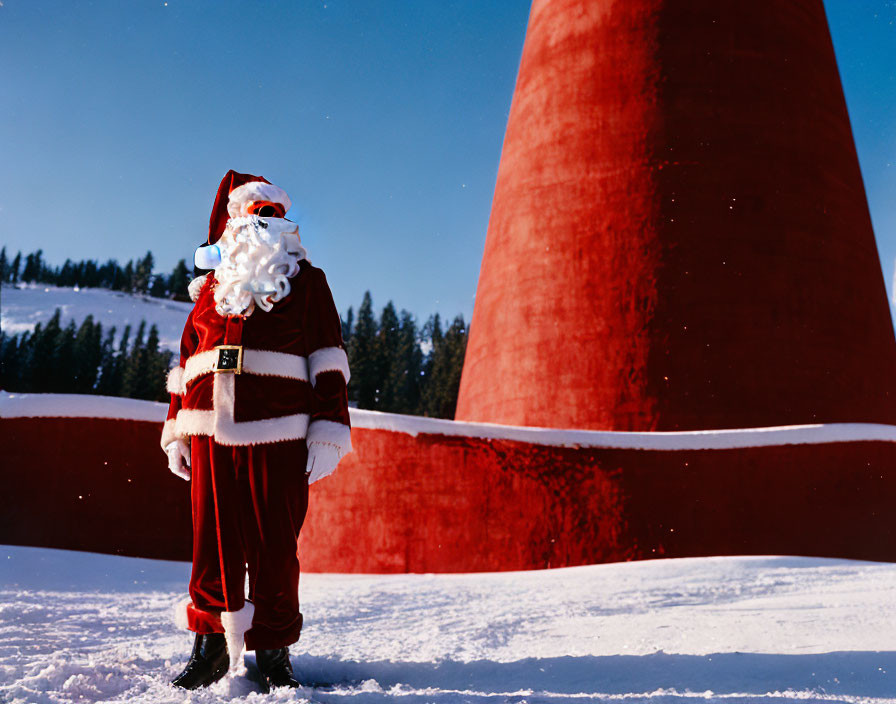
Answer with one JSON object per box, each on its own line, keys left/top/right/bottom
{"left": 0, "top": 0, "right": 896, "bottom": 322}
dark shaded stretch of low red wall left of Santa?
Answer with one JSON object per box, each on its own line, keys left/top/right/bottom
{"left": 0, "top": 418, "right": 192, "bottom": 560}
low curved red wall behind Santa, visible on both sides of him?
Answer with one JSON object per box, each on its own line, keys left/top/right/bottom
{"left": 0, "top": 418, "right": 896, "bottom": 572}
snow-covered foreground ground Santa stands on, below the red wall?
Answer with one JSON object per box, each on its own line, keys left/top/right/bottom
{"left": 0, "top": 547, "right": 896, "bottom": 704}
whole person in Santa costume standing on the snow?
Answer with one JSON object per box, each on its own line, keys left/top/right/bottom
{"left": 161, "top": 171, "right": 351, "bottom": 689}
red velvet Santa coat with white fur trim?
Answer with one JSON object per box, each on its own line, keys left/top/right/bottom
{"left": 162, "top": 259, "right": 351, "bottom": 458}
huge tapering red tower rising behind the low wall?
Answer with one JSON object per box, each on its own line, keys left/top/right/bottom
{"left": 456, "top": 0, "right": 896, "bottom": 431}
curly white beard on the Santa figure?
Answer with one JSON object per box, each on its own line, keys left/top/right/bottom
{"left": 215, "top": 215, "right": 307, "bottom": 316}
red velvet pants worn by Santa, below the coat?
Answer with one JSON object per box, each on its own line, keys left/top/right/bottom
{"left": 187, "top": 436, "right": 308, "bottom": 650}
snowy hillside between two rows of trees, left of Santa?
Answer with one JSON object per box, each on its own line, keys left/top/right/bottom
{"left": 0, "top": 284, "right": 193, "bottom": 352}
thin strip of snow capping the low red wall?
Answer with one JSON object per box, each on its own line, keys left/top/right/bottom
{"left": 0, "top": 391, "right": 896, "bottom": 450}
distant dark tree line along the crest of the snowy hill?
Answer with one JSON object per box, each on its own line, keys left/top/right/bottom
{"left": 0, "top": 247, "right": 191, "bottom": 301}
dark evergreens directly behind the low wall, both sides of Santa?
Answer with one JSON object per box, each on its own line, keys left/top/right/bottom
{"left": 0, "top": 280, "right": 469, "bottom": 418}
